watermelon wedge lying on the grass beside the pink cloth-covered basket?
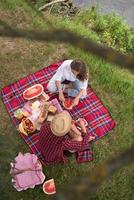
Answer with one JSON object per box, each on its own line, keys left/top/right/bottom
{"left": 43, "top": 179, "right": 56, "bottom": 194}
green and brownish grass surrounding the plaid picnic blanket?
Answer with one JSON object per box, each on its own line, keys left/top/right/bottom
{"left": 0, "top": 0, "right": 134, "bottom": 200}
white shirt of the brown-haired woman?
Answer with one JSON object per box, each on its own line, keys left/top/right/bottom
{"left": 50, "top": 60, "right": 88, "bottom": 89}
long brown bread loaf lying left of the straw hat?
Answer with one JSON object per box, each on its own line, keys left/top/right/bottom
{"left": 38, "top": 102, "right": 49, "bottom": 123}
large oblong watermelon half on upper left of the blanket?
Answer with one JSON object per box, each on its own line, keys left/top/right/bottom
{"left": 23, "top": 84, "right": 43, "bottom": 100}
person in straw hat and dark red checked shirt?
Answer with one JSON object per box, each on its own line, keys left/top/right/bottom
{"left": 39, "top": 111, "right": 94, "bottom": 164}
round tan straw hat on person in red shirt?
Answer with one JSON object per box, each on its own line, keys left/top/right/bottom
{"left": 51, "top": 111, "right": 72, "bottom": 137}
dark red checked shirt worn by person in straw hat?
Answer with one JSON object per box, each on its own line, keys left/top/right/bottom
{"left": 39, "top": 122, "right": 89, "bottom": 165}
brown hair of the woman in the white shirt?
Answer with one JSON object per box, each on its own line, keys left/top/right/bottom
{"left": 71, "top": 59, "right": 88, "bottom": 81}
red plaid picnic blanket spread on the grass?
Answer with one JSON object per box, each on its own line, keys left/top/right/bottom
{"left": 1, "top": 62, "right": 115, "bottom": 163}
